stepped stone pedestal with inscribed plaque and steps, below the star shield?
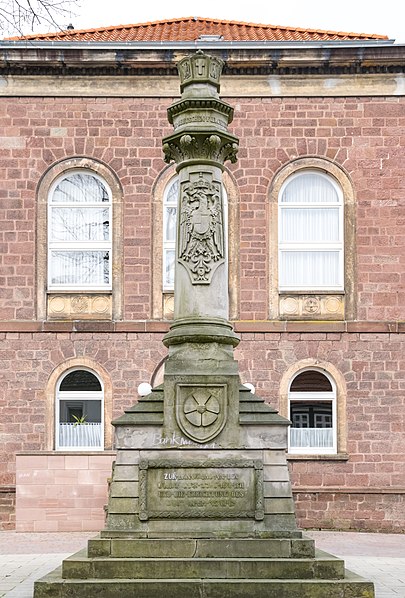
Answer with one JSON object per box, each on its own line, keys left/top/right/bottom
{"left": 34, "top": 387, "right": 374, "bottom": 598}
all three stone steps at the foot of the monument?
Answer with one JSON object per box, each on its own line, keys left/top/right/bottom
{"left": 34, "top": 536, "right": 374, "bottom": 598}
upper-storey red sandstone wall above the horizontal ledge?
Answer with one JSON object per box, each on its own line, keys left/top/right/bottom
{"left": 0, "top": 97, "right": 405, "bottom": 320}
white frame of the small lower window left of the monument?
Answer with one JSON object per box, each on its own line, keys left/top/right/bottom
{"left": 55, "top": 367, "right": 104, "bottom": 452}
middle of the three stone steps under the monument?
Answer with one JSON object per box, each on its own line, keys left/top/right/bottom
{"left": 62, "top": 553, "right": 344, "bottom": 580}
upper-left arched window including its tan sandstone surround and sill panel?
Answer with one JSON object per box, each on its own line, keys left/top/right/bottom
{"left": 36, "top": 157, "right": 123, "bottom": 320}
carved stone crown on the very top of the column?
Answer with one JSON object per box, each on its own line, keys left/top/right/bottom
{"left": 177, "top": 50, "right": 225, "bottom": 96}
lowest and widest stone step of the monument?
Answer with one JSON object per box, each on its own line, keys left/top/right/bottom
{"left": 35, "top": 569, "right": 374, "bottom": 598}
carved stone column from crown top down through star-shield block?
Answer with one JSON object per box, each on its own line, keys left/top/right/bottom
{"left": 163, "top": 50, "right": 243, "bottom": 445}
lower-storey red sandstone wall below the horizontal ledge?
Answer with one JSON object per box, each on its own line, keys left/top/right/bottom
{"left": 0, "top": 333, "right": 405, "bottom": 531}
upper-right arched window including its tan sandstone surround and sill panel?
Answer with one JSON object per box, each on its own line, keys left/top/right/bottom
{"left": 269, "top": 156, "right": 356, "bottom": 320}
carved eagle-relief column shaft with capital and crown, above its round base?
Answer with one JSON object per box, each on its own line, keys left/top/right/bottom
{"left": 163, "top": 51, "right": 238, "bottom": 330}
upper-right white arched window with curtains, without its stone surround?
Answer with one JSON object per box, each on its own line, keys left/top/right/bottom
{"left": 278, "top": 169, "right": 344, "bottom": 292}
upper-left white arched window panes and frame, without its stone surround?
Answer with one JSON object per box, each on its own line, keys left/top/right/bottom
{"left": 48, "top": 169, "right": 112, "bottom": 291}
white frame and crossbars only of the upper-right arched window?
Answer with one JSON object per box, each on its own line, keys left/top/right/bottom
{"left": 278, "top": 168, "right": 344, "bottom": 292}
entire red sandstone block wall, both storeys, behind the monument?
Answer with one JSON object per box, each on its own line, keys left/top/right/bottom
{"left": 0, "top": 97, "right": 405, "bottom": 531}
